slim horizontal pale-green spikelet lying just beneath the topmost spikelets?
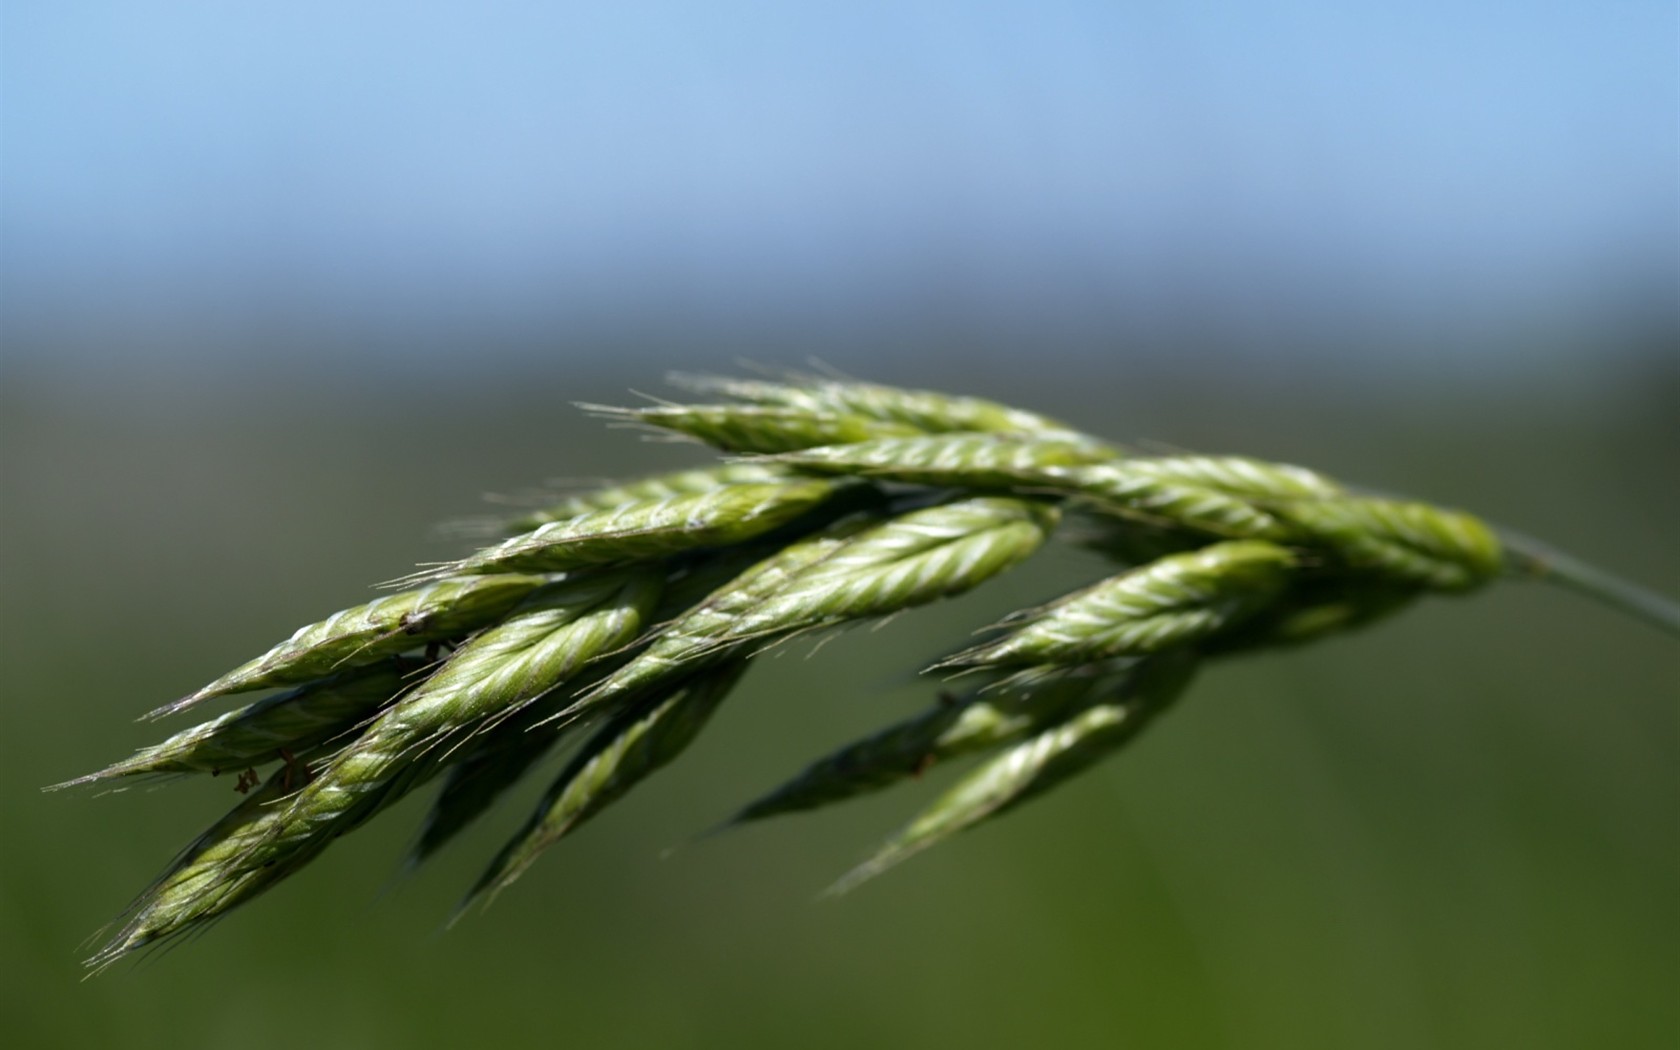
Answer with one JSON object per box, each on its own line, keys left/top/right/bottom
{"left": 754, "top": 433, "right": 1105, "bottom": 489}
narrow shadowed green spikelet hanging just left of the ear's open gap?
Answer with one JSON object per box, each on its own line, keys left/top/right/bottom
{"left": 460, "top": 659, "right": 748, "bottom": 909}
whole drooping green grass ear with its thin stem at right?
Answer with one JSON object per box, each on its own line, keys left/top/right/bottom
{"left": 59, "top": 367, "right": 1680, "bottom": 968}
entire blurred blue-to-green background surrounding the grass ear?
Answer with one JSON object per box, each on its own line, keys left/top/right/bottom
{"left": 0, "top": 0, "right": 1680, "bottom": 1050}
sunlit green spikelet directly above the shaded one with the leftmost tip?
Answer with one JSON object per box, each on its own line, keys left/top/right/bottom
{"left": 148, "top": 573, "right": 549, "bottom": 717}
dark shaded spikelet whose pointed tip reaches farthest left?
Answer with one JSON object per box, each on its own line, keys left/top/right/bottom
{"left": 57, "top": 657, "right": 425, "bottom": 788}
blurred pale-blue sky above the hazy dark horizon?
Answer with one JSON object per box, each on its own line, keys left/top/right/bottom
{"left": 0, "top": 0, "right": 1680, "bottom": 376}
